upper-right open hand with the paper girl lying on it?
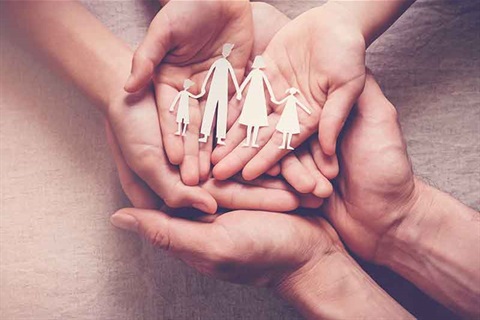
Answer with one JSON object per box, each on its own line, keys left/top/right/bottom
{"left": 212, "top": 4, "right": 365, "bottom": 180}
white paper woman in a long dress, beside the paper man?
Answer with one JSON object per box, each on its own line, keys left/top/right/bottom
{"left": 237, "top": 56, "right": 275, "bottom": 148}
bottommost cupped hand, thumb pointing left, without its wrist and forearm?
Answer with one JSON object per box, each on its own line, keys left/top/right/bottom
{"left": 111, "top": 208, "right": 343, "bottom": 286}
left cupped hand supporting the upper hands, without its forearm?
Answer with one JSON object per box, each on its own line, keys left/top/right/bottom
{"left": 106, "top": 89, "right": 300, "bottom": 213}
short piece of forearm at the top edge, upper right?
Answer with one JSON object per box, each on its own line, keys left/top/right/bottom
{"left": 326, "top": 0, "right": 415, "bottom": 47}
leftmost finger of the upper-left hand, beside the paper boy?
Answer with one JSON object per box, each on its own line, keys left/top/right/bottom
{"left": 155, "top": 83, "right": 185, "bottom": 166}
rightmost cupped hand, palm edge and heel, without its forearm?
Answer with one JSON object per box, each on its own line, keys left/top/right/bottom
{"left": 324, "top": 75, "right": 417, "bottom": 260}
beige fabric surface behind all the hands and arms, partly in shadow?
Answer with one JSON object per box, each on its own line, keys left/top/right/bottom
{"left": 0, "top": 0, "right": 480, "bottom": 320}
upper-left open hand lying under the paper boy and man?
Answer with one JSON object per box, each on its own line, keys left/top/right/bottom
{"left": 125, "top": 0, "right": 253, "bottom": 185}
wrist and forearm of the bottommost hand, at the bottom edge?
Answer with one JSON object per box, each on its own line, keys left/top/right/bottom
{"left": 278, "top": 252, "right": 413, "bottom": 319}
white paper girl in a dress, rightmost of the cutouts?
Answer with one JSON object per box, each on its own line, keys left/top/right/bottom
{"left": 275, "top": 88, "right": 312, "bottom": 150}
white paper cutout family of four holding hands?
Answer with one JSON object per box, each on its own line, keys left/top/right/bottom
{"left": 170, "top": 43, "right": 311, "bottom": 150}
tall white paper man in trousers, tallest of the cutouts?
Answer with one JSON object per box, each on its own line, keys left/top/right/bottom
{"left": 199, "top": 43, "right": 239, "bottom": 145}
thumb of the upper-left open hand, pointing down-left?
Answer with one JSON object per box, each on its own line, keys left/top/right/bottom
{"left": 125, "top": 11, "right": 171, "bottom": 92}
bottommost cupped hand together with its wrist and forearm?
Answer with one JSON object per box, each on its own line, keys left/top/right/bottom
{"left": 111, "top": 205, "right": 412, "bottom": 319}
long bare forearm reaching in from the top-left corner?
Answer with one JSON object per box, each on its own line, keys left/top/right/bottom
{"left": 2, "top": 1, "right": 131, "bottom": 108}
